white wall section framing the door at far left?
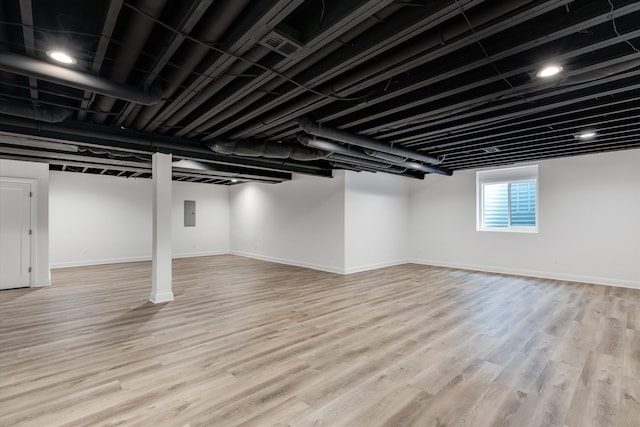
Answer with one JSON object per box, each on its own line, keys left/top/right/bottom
{"left": 0, "top": 159, "right": 51, "bottom": 287}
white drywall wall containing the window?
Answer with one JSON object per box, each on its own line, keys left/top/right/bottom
{"left": 410, "top": 150, "right": 640, "bottom": 288}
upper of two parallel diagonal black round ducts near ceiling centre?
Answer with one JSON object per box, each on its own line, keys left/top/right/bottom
{"left": 298, "top": 117, "right": 441, "bottom": 165}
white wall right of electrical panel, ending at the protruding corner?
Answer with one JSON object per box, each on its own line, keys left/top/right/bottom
{"left": 230, "top": 171, "right": 345, "bottom": 273}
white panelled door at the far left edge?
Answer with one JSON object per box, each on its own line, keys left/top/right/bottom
{"left": 0, "top": 181, "right": 31, "bottom": 289}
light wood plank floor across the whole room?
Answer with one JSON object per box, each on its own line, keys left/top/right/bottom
{"left": 0, "top": 256, "right": 640, "bottom": 427}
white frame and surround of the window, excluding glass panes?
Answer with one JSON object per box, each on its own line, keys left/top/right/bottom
{"left": 476, "top": 165, "right": 540, "bottom": 233}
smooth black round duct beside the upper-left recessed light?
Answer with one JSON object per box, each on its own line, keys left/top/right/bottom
{"left": 0, "top": 51, "right": 162, "bottom": 105}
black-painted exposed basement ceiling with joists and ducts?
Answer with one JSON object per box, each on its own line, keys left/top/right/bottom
{"left": 0, "top": 0, "right": 640, "bottom": 184}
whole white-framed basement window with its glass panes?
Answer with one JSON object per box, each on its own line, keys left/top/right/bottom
{"left": 476, "top": 165, "right": 538, "bottom": 233}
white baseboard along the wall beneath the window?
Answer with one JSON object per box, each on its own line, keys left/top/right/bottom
{"left": 409, "top": 259, "right": 640, "bottom": 289}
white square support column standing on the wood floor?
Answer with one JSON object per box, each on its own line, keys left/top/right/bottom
{"left": 149, "top": 153, "right": 173, "bottom": 304}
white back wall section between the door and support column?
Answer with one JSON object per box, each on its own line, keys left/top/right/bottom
{"left": 49, "top": 171, "right": 152, "bottom": 267}
